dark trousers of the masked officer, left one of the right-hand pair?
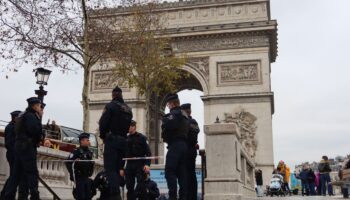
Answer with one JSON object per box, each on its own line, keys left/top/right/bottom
{"left": 165, "top": 141, "right": 187, "bottom": 200}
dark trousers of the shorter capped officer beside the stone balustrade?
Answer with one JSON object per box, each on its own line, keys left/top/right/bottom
{"left": 73, "top": 177, "right": 92, "bottom": 200}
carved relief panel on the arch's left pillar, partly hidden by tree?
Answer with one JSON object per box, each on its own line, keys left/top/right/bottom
{"left": 91, "top": 70, "right": 129, "bottom": 92}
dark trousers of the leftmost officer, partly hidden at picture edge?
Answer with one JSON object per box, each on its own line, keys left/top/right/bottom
{"left": 0, "top": 150, "right": 28, "bottom": 200}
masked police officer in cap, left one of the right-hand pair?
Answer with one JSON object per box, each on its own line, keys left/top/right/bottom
{"left": 162, "top": 94, "right": 189, "bottom": 200}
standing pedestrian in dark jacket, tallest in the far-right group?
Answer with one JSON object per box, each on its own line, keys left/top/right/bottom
{"left": 318, "top": 156, "right": 332, "bottom": 196}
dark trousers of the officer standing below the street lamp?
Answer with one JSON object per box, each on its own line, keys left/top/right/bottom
{"left": 5, "top": 142, "right": 39, "bottom": 200}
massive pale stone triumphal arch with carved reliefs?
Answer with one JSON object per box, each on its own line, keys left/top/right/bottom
{"left": 89, "top": 0, "right": 277, "bottom": 194}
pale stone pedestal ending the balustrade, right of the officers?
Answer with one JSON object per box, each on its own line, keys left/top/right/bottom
{"left": 204, "top": 123, "right": 255, "bottom": 200}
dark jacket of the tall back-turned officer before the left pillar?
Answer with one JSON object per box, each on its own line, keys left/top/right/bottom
{"left": 99, "top": 98, "right": 132, "bottom": 139}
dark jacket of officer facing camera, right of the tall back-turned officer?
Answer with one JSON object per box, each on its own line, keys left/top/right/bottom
{"left": 126, "top": 132, "right": 152, "bottom": 166}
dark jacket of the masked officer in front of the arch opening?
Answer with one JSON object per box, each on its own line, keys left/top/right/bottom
{"left": 162, "top": 107, "right": 189, "bottom": 144}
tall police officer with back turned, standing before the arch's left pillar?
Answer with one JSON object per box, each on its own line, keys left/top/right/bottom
{"left": 99, "top": 87, "right": 132, "bottom": 199}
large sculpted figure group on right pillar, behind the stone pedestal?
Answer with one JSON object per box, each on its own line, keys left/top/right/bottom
{"left": 223, "top": 108, "right": 258, "bottom": 158}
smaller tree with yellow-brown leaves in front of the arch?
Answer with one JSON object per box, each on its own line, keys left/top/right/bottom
{"left": 98, "top": 1, "right": 186, "bottom": 140}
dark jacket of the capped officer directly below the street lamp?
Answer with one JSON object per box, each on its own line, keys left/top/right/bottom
{"left": 15, "top": 107, "right": 43, "bottom": 147}
